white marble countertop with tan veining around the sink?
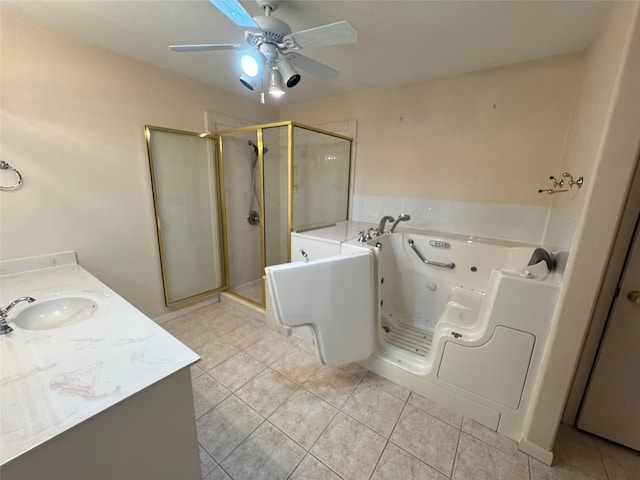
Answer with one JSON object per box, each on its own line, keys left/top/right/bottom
{"left": 0, "top": 252, "right": 199, "bottom": 464}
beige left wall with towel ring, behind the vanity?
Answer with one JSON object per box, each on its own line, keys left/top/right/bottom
{"left": 0, "top": 12, "right": 278, "bottom": 317}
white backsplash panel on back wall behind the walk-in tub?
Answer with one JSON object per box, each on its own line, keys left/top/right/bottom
{"left": 351, "top": 195, "right": 549, "bottom": 243}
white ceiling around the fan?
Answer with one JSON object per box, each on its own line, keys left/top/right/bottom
{"left": 0, "top": 0, "right": 611, "bottom": 104}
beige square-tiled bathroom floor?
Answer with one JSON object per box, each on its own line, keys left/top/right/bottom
{"left": 163, "top": 303, "right": 640, "bottom": 480}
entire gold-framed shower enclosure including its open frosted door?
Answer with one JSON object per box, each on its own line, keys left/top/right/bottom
{"left": 145, "top": 121, "right": 352, "bottom": 307}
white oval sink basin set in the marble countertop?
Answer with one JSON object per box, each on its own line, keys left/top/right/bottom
{"left": 13, "top": 294, "right": 103, "bottom": 330}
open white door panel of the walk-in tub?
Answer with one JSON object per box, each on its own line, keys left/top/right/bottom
{"left": 265, "top": 251, "right": 376, "bottom": 367}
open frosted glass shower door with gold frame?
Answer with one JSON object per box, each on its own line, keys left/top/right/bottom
{"left": 145, "top": 127, "right": 226, "bottom": 306}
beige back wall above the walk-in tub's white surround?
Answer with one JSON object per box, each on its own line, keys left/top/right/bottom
{"left": 280, "top": 54, "right": 583, "bottom": 206}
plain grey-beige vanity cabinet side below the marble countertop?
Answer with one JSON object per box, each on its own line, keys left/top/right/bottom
{"left": 0, "top": 367, "right": 200, "bottom": 480}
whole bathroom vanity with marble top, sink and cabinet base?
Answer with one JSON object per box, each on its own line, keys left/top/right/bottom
{"left": 0, "top": 252, "right": 200, "bottom": 480}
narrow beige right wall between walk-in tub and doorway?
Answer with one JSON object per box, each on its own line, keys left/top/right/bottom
{"left": 525, "top": 2, "right": 640, "bottom": 450}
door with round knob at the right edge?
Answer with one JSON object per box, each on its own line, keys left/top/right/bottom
{"left": 578, "top": 218, "right": 640, "bottom": 450}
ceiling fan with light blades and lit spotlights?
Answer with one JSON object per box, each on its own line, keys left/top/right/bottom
{"left": 169, "top": 0, "right": 358, "bottom": 98}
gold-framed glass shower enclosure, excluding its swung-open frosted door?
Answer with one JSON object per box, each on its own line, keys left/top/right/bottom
{"left": 218, "top": 122, "right": 351, "bottom": 306}
